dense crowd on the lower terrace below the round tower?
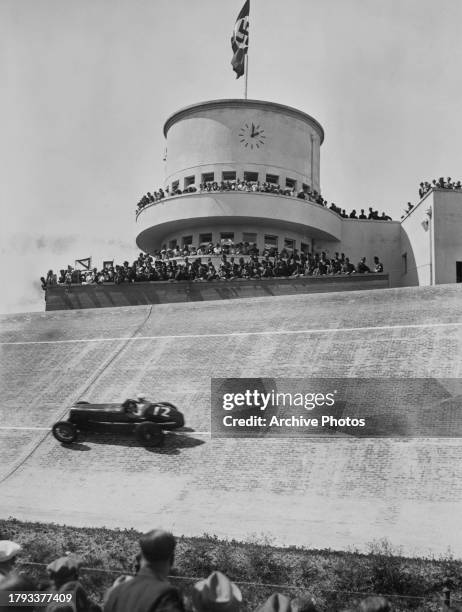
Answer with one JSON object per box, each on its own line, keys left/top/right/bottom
{"left": 40, "top": 245, "right": 383, "bottom": 290}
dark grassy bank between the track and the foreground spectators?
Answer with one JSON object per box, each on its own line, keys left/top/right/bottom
{"left": 0, "top": 519, "right": 462, "bottom": 611}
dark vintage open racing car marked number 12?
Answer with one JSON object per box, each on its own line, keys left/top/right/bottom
{"left": 52, "top": 399, "right": 184, "bottom": 447}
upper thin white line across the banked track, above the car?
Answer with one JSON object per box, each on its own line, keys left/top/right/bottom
{"left": 0, "top": 321, "right": 462, "bottom": 345}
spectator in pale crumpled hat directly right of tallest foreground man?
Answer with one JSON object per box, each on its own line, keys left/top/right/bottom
{"left": 192, "top": 572, "right": 242, "bottom": 612}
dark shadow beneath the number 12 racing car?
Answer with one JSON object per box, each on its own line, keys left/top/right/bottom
{"left": 70, "top": 428, "right": 204, "bottom": 455}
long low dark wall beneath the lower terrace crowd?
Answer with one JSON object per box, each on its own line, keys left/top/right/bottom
{"left": 45, "top": 274, "right": 389, "bottom": 310}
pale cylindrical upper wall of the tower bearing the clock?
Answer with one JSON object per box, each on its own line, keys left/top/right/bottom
{"left": 164, "top": 100, "right": 324, "bottom": 191}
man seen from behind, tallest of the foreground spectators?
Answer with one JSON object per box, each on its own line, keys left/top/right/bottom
{"left": 104, "top": 529, "right": 185, "bottom": 612}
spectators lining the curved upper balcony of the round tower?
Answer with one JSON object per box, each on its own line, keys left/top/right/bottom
{"left": 136, "top": 179, "right": 391, "bottom": 221}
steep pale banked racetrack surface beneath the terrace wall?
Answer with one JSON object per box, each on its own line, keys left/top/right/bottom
{"left": 0, "top": 285, "right": 462, "bottom": 556}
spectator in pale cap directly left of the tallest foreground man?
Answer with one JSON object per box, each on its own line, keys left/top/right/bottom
{"left": 46, "top": 555, "right": 101, "bottom": 612}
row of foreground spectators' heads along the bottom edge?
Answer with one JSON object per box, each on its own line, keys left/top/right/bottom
{"left": 0, "top": 529, "right": 398, "bottom": 612}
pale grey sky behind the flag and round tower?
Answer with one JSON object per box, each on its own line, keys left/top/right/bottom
{"left": 0, "top": 0, "right": 462, "bottom": 313}
